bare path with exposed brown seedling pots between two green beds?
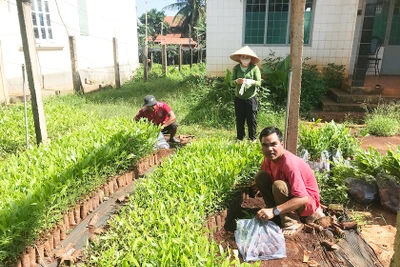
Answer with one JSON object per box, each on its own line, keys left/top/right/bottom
{"left": 15, "top": 149, "right": 175, "bottom": 267}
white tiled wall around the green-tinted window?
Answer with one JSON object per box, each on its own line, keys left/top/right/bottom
{"left": 207, "top": 0, "right": 359, "bottom": 76}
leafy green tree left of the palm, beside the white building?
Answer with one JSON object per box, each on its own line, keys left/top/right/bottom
{"left": 138, "top": 8, "right": 171, "bottom": 45}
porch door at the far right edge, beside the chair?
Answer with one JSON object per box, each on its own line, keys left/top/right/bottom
{"left": 381, "top": 0, "right": 400, "bottom": 75}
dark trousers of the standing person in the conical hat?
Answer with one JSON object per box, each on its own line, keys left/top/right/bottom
{"left": 235, "top": 97, "right": 258, "bottom": 140}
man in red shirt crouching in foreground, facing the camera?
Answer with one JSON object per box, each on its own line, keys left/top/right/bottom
{"left": 255, "top": 127, "right": 325, "bottom": 236}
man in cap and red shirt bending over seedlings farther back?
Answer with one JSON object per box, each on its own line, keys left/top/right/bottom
{"left": 135, "top": 95, "right": 180, "bottom": 143}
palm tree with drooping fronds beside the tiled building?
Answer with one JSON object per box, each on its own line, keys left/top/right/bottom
{"left": 163, "top": 0, "right": 206, "bottom": 37}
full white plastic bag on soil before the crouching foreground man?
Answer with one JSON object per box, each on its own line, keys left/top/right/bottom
{"left": 235, "top": 218, "right": 286, "bottom": 262}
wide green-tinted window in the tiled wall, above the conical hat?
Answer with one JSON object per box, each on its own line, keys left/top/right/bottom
{"left": 244, "top": 0, "right": 314, "bottom": 44}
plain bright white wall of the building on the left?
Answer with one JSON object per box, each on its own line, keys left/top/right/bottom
{"left": 0, "top": 0, "right": 139, "bottom": 93}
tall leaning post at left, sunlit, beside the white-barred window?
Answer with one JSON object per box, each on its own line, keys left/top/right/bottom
{"left": 17, "top": 0, "right": 48, "bottom": 145}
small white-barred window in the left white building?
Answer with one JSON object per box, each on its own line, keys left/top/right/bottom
{"left": 31, "top": 0, "right": 53, "bottom": 40}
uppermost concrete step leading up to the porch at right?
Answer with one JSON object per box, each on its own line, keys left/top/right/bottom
{"left": 327, "top": 88, "right": 400, "bottom": 104}
